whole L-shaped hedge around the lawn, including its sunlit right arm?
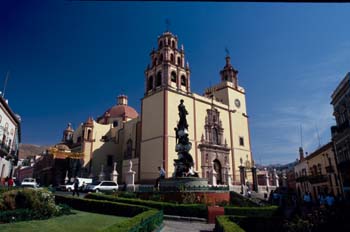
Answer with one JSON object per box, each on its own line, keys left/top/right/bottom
{"left": 56, "top": 195, "right": 163, "bottom": 232}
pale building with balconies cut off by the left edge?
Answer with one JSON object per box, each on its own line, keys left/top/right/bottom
{"left": 0, "top": 95, "right": 21, "bottom": 181}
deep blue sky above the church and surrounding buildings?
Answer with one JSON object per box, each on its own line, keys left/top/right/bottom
{"left": 0, "top": 0, "right": 350, "bottom": 164}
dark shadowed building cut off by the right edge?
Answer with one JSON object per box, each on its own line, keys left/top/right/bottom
{"left": 331, "top": 73, "right": 350, "bottom": 200}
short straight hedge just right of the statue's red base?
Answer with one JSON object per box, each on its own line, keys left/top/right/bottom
{"left": 225, "top": 206, "right": 279, "bottom": 217}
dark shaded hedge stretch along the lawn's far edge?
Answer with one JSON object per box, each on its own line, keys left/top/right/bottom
{"left": 55, "top": 195, "right": 150, "bottom": 217}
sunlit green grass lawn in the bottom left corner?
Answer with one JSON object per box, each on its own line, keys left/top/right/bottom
{"left": 0, "top": 210, "right": 127, "bottom": 232}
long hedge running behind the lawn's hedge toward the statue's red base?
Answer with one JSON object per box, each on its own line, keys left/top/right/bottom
{"left": 85, "top": 193, "right": 208, "bottom": 218}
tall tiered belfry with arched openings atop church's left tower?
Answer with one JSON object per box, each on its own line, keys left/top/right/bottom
{"left": 145, "top": 31, "right": 191, "bottom": 96}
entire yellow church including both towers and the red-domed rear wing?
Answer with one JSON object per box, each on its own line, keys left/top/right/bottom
{"left": 58, "top": 32, "right": 254, "bottom": 187}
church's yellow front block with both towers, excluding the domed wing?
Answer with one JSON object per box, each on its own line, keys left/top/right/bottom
{"left": 139, "top": 31, "right": 253, "bottom": 184}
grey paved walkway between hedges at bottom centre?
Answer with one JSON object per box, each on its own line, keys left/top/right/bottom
{"left": 161, "top": 220, "right": 215, "bottom": 232}
